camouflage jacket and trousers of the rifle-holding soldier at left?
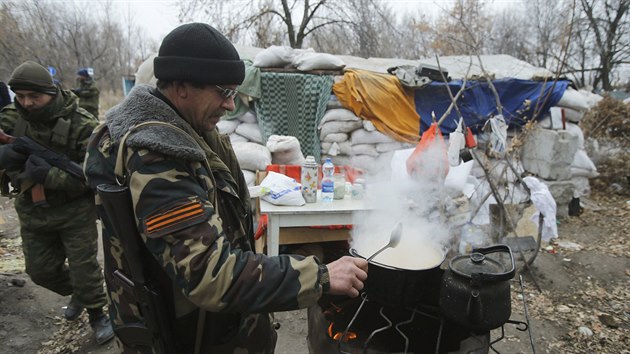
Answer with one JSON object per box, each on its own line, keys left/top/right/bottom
{"left": 0, "top": 91, "right": 107, "bottom": 308}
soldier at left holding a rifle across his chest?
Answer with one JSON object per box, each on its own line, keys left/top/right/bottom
{"left": 0, "top": 61, "right": 113, "bottom": 343}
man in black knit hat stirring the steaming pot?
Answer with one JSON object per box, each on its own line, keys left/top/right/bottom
{"left": 85, "top": 23, "right": 367, "bottom": 353}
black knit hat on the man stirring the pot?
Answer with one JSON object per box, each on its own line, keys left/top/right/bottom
{"left": 153, "top": 23, "right": 245, "bottom": 85}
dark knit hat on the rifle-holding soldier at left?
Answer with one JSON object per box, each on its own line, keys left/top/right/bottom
{"left": 9, "top": 61, "right": 57, "bottom": 96}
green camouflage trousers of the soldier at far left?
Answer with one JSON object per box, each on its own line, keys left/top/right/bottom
{"left": 16, "top": 197, "right": 107, "bottom": 308}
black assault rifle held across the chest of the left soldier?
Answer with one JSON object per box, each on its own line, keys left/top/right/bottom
{"left": 0, "top": 129, "right": 85, "bottom": 206}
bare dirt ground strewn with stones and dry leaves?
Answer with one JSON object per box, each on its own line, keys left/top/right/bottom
{"left": 0, "top": 184, "right": 630, "bottom": 354}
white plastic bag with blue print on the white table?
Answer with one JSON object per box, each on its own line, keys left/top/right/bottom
{"left": 260, "top": 171, "right": 306, "bottom": 206}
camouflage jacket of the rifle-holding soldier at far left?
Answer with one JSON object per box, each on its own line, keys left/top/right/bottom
{"left": 0, "top": 90, "right": 98, "bottom": 213}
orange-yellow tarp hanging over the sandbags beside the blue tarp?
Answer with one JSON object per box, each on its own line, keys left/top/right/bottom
{"left": 333, "top": 69, "right": 420, "bottom": 143}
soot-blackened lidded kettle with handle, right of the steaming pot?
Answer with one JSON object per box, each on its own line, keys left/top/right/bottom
{"left": 439, "top": 245, "right": 515, "bottom": 332}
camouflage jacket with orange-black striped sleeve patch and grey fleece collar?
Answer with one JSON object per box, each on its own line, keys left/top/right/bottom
{"left": 85, "top": 85, "right": 322, "bottom": 352}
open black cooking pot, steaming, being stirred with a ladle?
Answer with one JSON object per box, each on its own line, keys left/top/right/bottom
{"left": 350, "top": 246, "right": 445, "bottom": 308}
